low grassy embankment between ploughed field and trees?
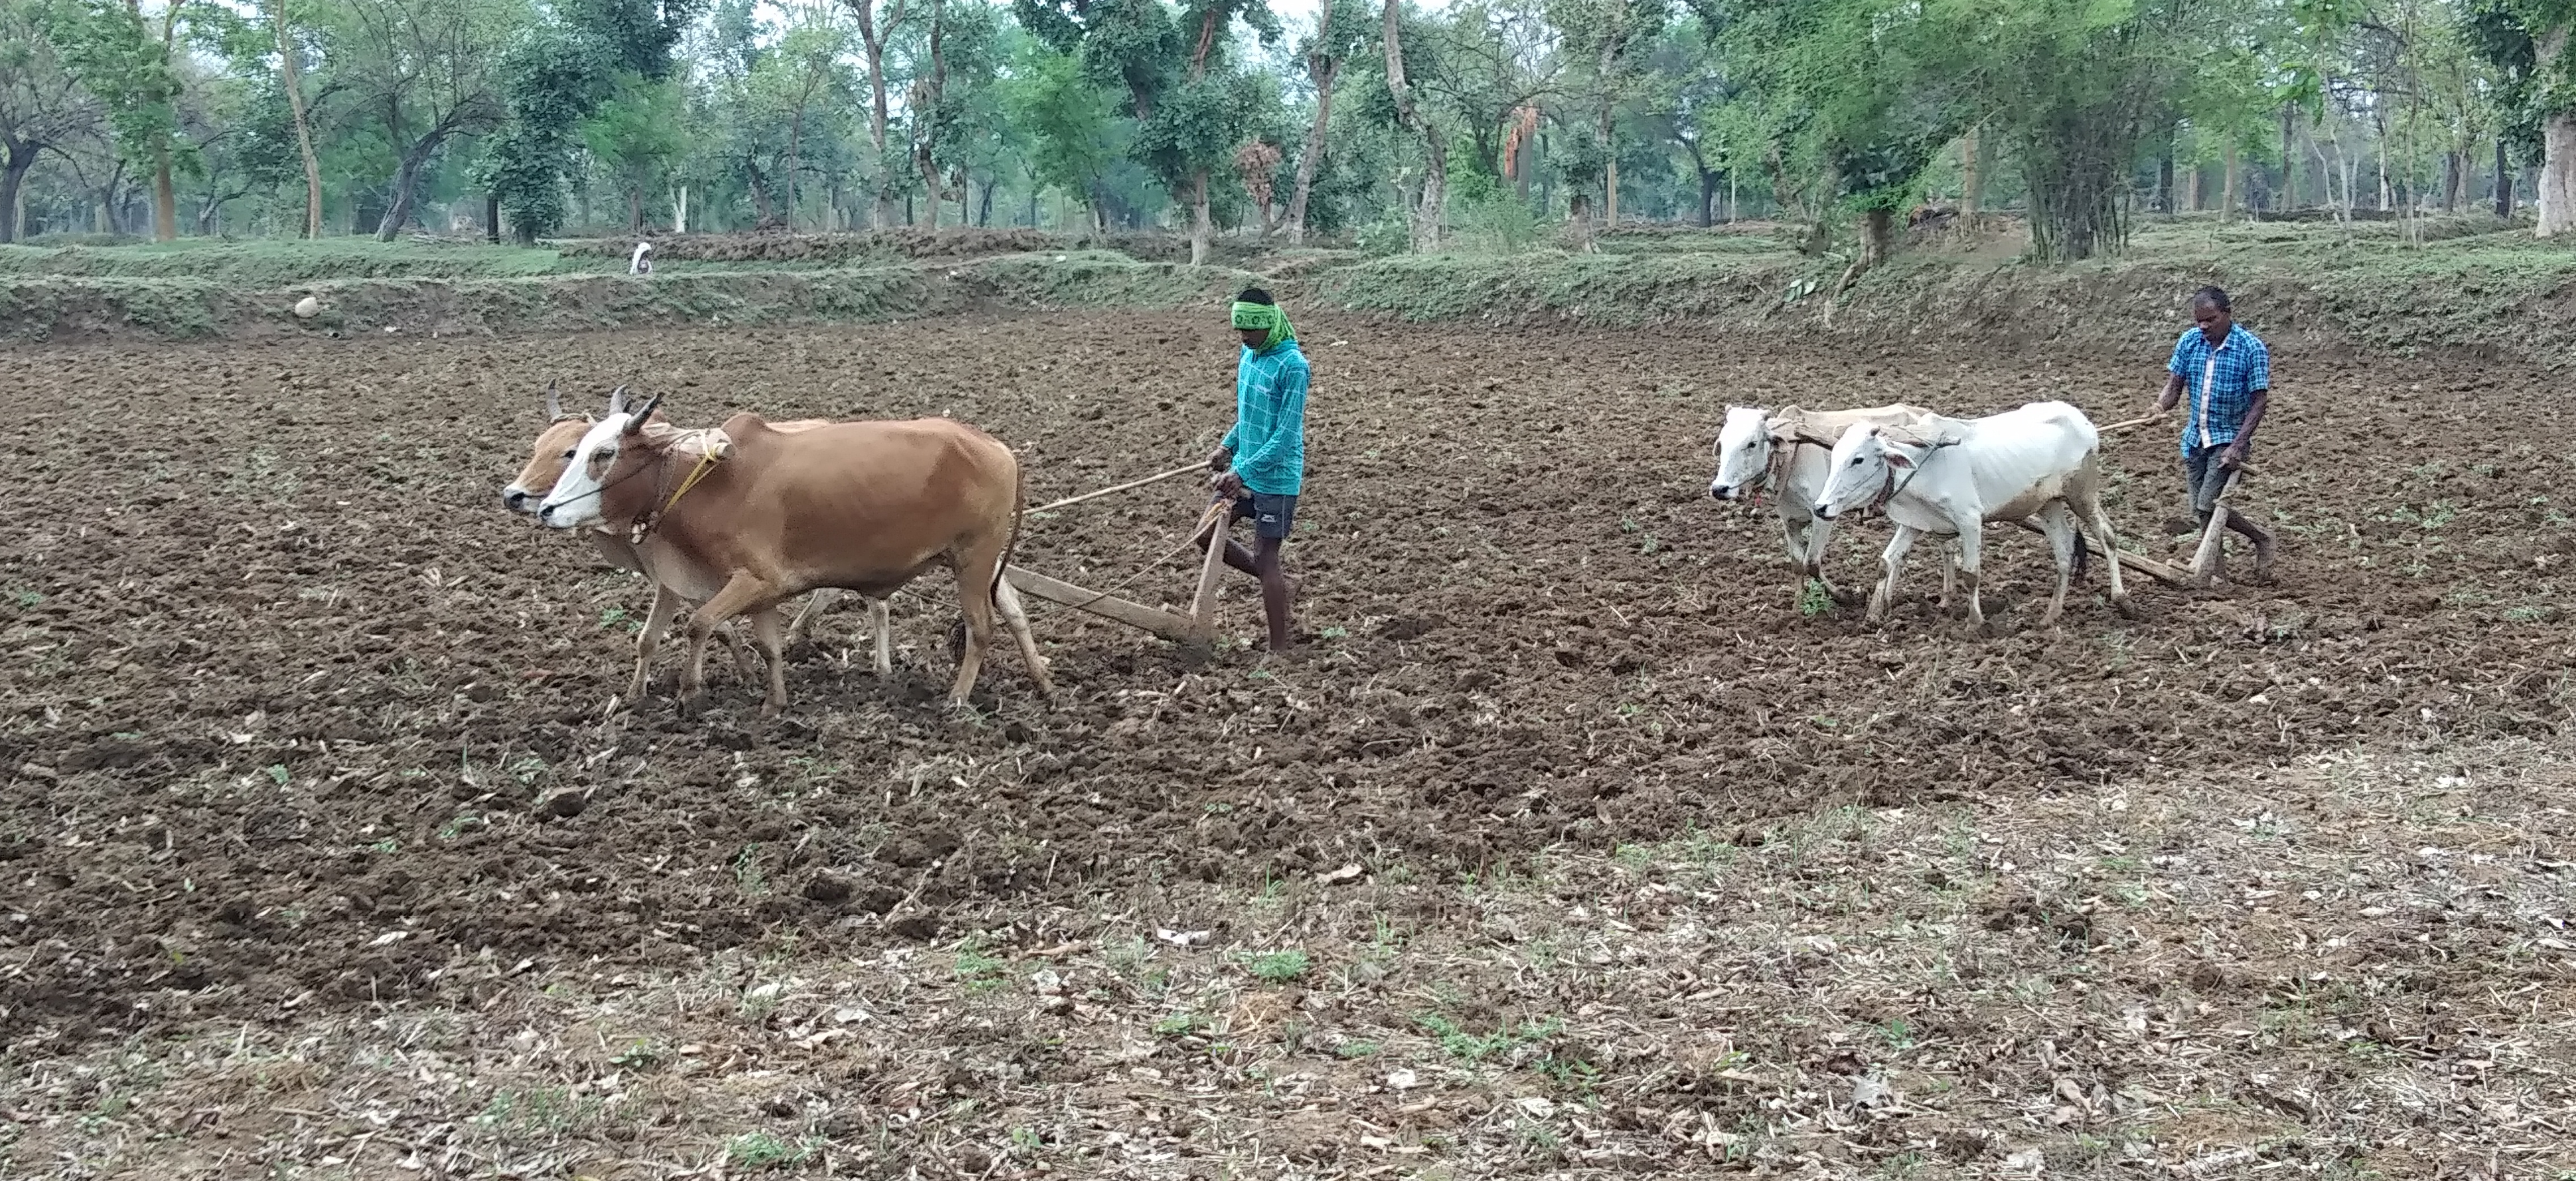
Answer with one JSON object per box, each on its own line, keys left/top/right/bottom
{"left": 0, "top": 217, "right": 2576, "bottom": 369}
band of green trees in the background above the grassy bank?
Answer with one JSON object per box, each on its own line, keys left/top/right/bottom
{"left": 0, "top": 0, "right": 2576, "bottom": 268}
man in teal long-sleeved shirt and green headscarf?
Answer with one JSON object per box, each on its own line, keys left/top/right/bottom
{"left": 1198, "top": 286, "right": 1308, "bottom": 652}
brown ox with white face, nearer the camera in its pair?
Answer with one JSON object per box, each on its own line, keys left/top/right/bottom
{"left": 536, "top": 400, "right": 1054, "bottom": 714}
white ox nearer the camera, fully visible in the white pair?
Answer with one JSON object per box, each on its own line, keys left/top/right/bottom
{"left": 1816, "top": 402, "right": 2130, "bottom": 626}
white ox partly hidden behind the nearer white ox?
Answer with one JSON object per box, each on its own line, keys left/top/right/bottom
{"left": 1708, "top": 402, "right": 1950, "bottom": 606}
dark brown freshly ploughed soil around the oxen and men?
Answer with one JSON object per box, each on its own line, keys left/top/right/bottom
{"left": 0, "top": 315, "right": 2576, "bottom": 1044}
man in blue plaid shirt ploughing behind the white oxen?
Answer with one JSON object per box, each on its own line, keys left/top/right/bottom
{"left": 2156, "top": 286, "right": 2272, "bottom": 578}
